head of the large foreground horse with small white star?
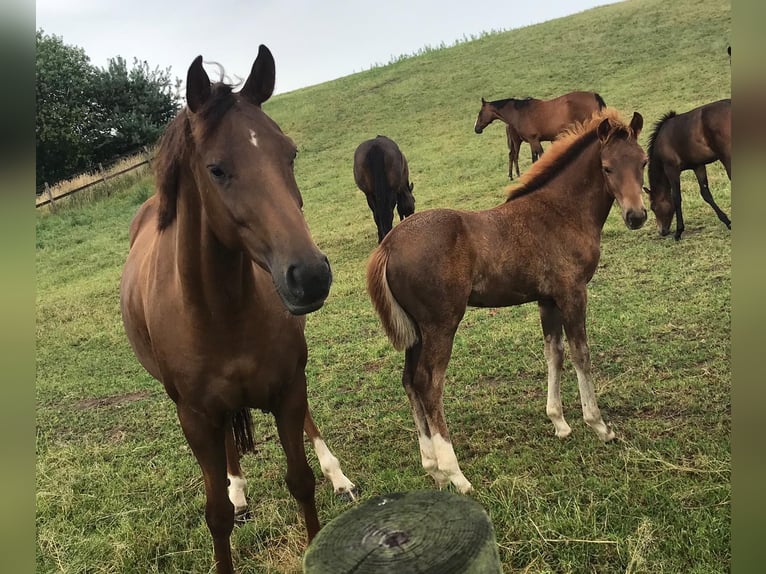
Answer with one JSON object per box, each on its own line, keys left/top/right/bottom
{"left": 181, "top": 45, "right": 332, "bottom": 315}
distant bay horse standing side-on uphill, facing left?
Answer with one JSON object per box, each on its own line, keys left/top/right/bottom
{"left": 473, "top": 92, "right": 606, "bottom": 173}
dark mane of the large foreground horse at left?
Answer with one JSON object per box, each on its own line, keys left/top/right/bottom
{"left": 154, "top": 82, "right": 236, "bottom": 231}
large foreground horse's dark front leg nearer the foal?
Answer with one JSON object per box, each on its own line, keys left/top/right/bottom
{"left": 274, "top": 380, "right": 319, "bottom": 542}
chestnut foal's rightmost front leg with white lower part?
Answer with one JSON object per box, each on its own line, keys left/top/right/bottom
{"left": 562, "top": 294, "right": 615, "bottom": 442}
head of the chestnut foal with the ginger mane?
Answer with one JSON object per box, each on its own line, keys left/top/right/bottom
{"left": 596, "top": 112, "right": 647, "bottom": 229}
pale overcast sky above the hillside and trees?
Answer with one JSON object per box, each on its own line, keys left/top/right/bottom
{"left": 36, "top": 0, "right": 614, "bottom": 97}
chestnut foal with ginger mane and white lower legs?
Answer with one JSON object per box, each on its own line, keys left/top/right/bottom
{"left": 367, "top": 109, "right": 646, "bottom": 492}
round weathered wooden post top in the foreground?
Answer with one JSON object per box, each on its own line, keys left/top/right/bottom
{"left": 303, "top": 490, "right": 502, "bottom": 574}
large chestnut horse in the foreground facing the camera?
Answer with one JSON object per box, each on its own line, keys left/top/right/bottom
{"left": 120, "top": 45, "right": 355, "bottom": 574}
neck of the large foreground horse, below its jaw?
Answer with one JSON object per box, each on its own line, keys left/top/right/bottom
{"left": 174, "top": 173, "right": 253, "bottom": 307}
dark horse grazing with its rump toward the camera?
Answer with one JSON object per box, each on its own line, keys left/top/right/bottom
{"left": 354, "top": 135, "right": 415, "bottom": 243}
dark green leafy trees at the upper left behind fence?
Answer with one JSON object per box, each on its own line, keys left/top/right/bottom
{"left": 35, "top": 30, "right": 181, "bottom": 189}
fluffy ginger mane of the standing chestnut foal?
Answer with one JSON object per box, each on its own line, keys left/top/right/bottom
{"left": 506, "top": 107, "right": 630, "bottom": 201}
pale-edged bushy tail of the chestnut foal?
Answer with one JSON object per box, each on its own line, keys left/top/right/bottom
{"left": 367, "top": 246, "right": 418, "bottom": 351}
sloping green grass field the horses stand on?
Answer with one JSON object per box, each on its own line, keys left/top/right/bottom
{"left": 36, "top": 0, "right": 731, "bottom": 574}
